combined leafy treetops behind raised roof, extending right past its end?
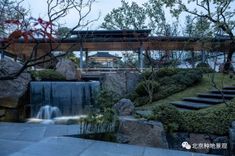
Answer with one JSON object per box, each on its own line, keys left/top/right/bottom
{"left": 101, "top": 0, "right": 178, "bottom": 36}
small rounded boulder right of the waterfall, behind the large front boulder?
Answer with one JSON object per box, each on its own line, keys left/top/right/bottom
{"left": 113, "top": 99, "right": 135, "bottom": 116}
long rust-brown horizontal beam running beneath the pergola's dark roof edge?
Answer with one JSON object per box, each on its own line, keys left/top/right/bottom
{"left": 2, "top": 37, "right": 235, "bottom": 58}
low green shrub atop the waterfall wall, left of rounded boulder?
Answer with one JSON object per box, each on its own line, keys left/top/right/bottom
{"left": 31, "top": 69, "right": 66, "bottom": 81}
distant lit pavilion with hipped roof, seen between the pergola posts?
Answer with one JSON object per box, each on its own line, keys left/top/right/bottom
{"left": 88, "top": 52, "right": 122, "bottom": 68}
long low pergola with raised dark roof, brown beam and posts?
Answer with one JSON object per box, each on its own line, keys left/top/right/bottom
{"left": 0, "top": 30, "right": 235, "bottom": 69}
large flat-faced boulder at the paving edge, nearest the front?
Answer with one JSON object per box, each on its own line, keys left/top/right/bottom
{"left": 117, "top": 117, "right": 168, "bottom": 148}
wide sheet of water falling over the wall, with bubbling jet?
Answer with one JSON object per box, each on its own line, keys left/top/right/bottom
{"left": 30, "top": 81, "right": 100, "bottom": 119}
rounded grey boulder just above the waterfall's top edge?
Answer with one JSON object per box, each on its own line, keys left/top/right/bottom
{"left": 56, "top": 58, "right": 81, "bottom": 80}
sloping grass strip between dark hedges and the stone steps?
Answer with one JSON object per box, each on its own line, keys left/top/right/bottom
{"left": 137, "top": 73, "right": 235, "bottom": 110}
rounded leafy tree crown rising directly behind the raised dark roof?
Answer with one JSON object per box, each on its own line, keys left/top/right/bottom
{"left": 101, "top": 0, "right": 146, "bottom": 30}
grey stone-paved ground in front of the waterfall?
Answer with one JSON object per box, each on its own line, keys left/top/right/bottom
{"left": 0, "top": 123, "right": 213, "bottom": 156}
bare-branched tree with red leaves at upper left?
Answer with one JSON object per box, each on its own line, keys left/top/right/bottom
{"left": 0, "top": 0, "right": 97, "bottom": 80}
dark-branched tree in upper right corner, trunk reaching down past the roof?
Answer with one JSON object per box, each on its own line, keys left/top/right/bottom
{"left": 162, "top": 0, "right": 235, "bottom": 71}
